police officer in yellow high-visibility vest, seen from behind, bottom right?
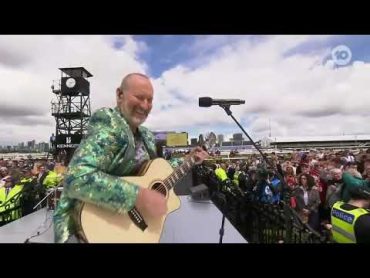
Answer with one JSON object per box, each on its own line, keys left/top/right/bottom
{"left": 331, "top": 186, "right": 370, "bottom": 243}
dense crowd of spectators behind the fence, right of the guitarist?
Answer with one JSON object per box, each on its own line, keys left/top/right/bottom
{"left": 210, "top": 149, "right": 370, "bottom": 237}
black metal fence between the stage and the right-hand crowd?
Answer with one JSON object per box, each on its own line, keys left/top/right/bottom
{"left": 195, "top": 165, "right": 331, "bottom": 243}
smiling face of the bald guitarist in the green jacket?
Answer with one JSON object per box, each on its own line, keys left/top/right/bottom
{"left": 117, "top": 75, "right": 153, "bottom": 131}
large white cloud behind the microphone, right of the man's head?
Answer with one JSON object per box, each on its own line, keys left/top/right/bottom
{"left": 148, "top": 36, "right": 370, "bottom": 140}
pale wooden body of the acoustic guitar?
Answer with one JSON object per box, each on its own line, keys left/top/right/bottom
{"left": 77, "top": 158, "right": 180, "bottom": 243}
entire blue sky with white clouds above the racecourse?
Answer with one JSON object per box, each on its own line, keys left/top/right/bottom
{"left": 0, "top": 35, "right": 370, "bottom": 145}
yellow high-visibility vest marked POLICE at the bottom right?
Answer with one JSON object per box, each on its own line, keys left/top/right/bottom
{"left": 331, "top": 201, "right": 370, "bottom": 243}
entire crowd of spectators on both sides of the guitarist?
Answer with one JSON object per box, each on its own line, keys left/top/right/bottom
{"left": 0, "top": 142, "right": 370, "bottom": 242}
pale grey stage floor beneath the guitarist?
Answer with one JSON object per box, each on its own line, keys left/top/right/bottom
{"left": 0, "top": 195, "right": 247, "bottom": 243}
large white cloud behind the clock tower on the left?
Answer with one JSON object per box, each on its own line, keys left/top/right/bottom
{"left": 0, "top": 35, "right": 147, "bottom": 144}
